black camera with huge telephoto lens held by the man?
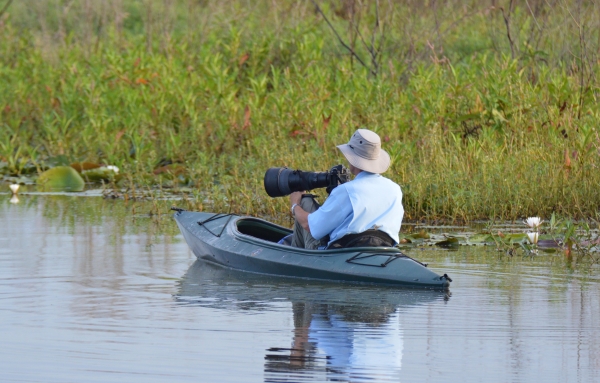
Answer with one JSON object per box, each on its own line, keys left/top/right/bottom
{"left": 264, "top": 165, "right": 349, "bottom": 197}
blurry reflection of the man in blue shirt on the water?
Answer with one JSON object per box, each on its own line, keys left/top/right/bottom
{"left": 265, "top": 302, "right": 404, "bottom": 382}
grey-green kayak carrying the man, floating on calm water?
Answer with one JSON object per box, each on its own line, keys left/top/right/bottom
{"left": 175, "top": 210, "right": 450, "bottom": 288}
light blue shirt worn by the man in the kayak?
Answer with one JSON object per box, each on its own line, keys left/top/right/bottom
{"left": 308, "top": 171, "right": 404, "bottom": 243}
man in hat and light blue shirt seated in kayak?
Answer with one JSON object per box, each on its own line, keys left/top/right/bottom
{"left": 290, "top": 129, "right": 404, "bottom": 250}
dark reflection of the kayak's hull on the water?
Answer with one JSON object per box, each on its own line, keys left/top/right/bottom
{"left": 176, "top": 260, "right": 449, "bottom": 312}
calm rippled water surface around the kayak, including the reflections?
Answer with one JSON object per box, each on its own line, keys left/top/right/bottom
{"left": 0, "top": 195, "right": 600, "bottom": 383}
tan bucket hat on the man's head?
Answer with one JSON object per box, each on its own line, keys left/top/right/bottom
{"left": 337, "top": 129, "right": 390, "bottom": 174}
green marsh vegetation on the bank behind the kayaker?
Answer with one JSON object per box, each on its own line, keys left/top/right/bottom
{"left": 0, "top": 0, "right": 600, "bottom": 219}
